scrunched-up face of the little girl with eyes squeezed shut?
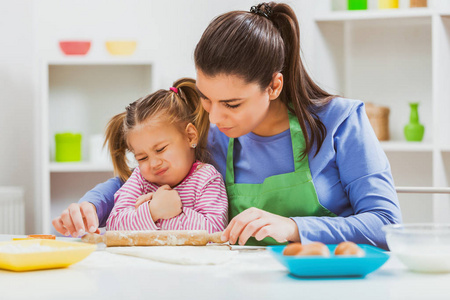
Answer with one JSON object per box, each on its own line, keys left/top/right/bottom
{"left": 127, "top": 121, "right": 197, "bottom": 187}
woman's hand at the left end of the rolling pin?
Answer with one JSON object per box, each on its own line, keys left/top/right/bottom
{"left": 52, "top": 201, "right": 100, "bottom": 237}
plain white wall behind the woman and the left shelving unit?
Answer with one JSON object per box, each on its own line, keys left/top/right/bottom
{"left": 0, "top": 0, "right": 314, "bottom": 233}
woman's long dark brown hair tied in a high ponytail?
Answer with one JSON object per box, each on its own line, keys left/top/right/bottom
{"left": 194, "top": 2, "right": 334, "bottom": 157}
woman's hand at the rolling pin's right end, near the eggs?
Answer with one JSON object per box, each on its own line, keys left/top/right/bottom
{"left": 222, "top": 207, "right": 300, "bottom": 246}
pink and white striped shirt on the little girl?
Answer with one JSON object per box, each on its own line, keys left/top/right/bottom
{"left": 106, "top": 161, "right": 228, "bottom": 233}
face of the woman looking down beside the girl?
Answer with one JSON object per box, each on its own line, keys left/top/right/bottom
{"left": 197, "top": 70, "right": 270, "bottom": 138}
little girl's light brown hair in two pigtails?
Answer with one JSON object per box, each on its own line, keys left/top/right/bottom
{"left": 105, "top": 78, "right": 209, "bottom": 181}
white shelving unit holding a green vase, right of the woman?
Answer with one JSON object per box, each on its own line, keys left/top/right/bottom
{"left": 313, "top": 7, "right": 450, "bottom": 222}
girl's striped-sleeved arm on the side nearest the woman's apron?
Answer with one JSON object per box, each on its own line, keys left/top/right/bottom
{"left": 160, "top": 171, "right": 228, "bottom": 233}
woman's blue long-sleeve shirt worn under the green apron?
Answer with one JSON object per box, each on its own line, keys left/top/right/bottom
{"left": 80, "top": 98, "right": 401, "bottom": 249}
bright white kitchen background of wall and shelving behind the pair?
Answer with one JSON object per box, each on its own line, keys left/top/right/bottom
{"left": 0, "top": 0, "right": 450, "bottom": 234}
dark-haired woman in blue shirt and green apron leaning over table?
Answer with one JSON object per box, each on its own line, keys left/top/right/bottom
{"left": 54, "top": 3, "right": 401, "bottom": 248}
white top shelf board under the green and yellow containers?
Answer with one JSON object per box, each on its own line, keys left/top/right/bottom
{"left": 314, "top": 8, "right": 436, "bottom": 22}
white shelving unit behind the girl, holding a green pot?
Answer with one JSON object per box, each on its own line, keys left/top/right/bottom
{"left": 36, "top": 56, "right": 157, "bottom": 233}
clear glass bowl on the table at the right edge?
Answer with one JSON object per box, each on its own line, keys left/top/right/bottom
{"left": 383, "top": 224, "right": 450, "bottom": 273}
